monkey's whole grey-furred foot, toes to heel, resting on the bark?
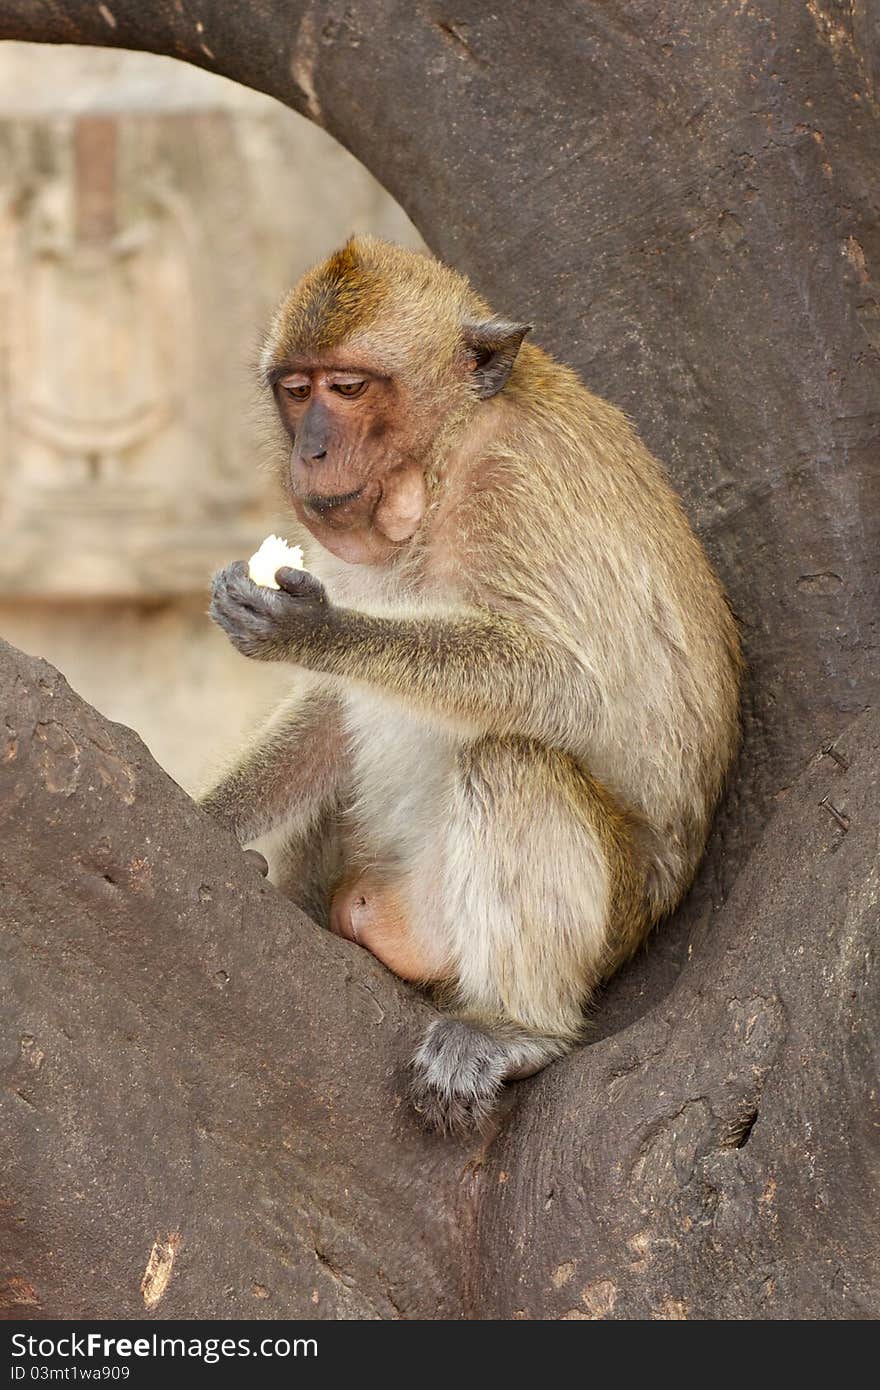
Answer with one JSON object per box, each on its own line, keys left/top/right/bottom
{"left": 410, "top": 1016, "right": 573, "bottom": 1134}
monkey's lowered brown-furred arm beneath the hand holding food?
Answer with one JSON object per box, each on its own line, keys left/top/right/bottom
{"left": 197, "top": 687, "right": 345, "bottom": 844}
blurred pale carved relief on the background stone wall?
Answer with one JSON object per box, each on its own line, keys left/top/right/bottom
{"left": 7, "top": 117, "right": 198, "bottom": 595}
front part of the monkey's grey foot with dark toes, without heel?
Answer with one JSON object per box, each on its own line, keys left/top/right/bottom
{"left": 410, "top": 1019, "right": 510, "bottom": 1134}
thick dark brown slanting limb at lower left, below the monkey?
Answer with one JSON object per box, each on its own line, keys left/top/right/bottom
{"left": 0, "top": 644, "right": 478, "bottom": 1318}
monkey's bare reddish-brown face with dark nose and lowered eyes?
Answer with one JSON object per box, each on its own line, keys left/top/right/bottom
{"left": 268, "top": 356, "right": 430, "bottom": 564}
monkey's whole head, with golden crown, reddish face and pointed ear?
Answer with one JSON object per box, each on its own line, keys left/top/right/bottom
{"left": 260, "top": 238, "right": 528, "bottom": 564}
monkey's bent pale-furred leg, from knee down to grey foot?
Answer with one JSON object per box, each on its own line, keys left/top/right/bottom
{"left": 412, "top": 737, "right": 645, "bottom": 1130}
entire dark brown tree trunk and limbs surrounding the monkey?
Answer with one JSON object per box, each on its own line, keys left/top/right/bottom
{"left": 0, "top": 0, "right": 880, "bottom": 1318}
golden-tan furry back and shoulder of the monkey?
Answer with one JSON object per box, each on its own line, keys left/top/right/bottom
{"left": 450, "top": 345, "right": 741, "bottom": 912}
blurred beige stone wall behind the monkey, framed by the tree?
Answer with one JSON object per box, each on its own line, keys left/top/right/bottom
{"left": 0, "top": 43, "right": 420, "bottom": 790}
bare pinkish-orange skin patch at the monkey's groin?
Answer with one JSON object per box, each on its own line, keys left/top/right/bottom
{"left": 329, "top": 872, "right": 448, "bottom": 983}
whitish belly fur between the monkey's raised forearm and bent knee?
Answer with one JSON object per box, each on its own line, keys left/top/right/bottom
{"left": 339, "top": 692, "right": 456, "bottom": 865}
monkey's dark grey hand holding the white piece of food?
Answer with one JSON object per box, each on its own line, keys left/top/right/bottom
{"left": 209, "top": 560, "right": 334, "bottom": 662}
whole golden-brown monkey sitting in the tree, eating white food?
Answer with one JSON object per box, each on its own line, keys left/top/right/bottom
{"left": 202, "top": 236, "right": 742, "bottom": 1131}
